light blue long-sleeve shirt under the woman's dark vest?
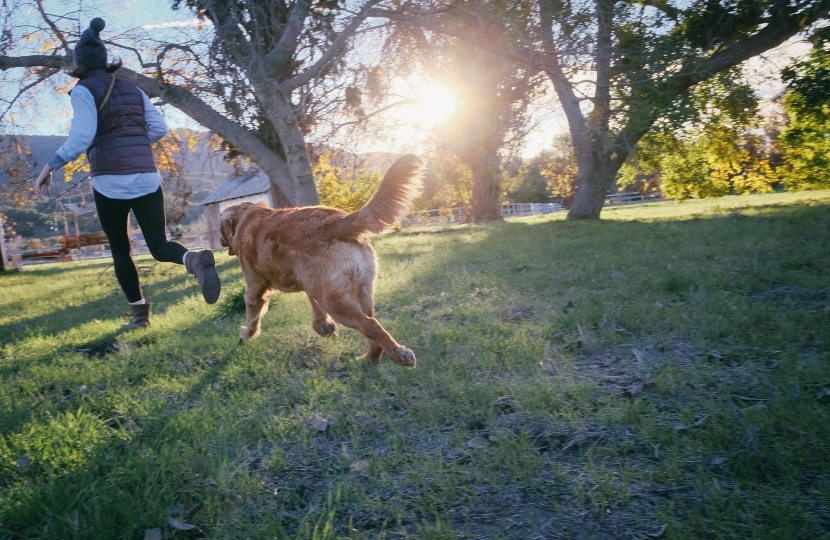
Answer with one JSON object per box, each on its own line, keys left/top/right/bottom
{"left": 49, "top": 86, "right": 167, "bottom": 199}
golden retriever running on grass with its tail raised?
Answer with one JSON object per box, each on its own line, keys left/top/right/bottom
{"left": 219, "top": 154, "right": 423, "bottom": 367}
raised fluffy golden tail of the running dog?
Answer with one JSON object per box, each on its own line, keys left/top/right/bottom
{"left": 333, "top": 154, "right": 424, "bottom": 240}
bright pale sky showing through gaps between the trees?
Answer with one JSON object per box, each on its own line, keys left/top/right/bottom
{"left": 0, "top": 0, "right": 809, "bottom": 157}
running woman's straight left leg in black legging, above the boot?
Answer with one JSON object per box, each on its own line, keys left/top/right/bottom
{"left": 94, "top": 191, "right": 142, "bottom": 303}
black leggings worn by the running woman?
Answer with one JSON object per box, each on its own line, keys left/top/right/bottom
{"left": 95, "top": 186, "right": 187, "bottom": 302}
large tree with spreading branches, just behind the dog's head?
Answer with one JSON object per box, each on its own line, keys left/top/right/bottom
{"left": 0, "top": 0, "right": 394, "bottom": 206}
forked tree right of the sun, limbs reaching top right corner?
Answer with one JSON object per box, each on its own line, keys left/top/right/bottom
{"left": 528, "top": 0, "right": 830, "bottom": 219}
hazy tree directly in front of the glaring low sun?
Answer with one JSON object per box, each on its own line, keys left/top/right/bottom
{"left": 374, "top": 0, "right": 539, "bottom": 222}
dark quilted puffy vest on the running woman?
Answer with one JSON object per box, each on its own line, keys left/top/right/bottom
{"left": 78, "top": 69, "right": 156, "bottom": 176}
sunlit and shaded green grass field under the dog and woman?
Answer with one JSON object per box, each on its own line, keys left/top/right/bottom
{"left": 0, "top": 192, "right": 830, "bottom": 540}
